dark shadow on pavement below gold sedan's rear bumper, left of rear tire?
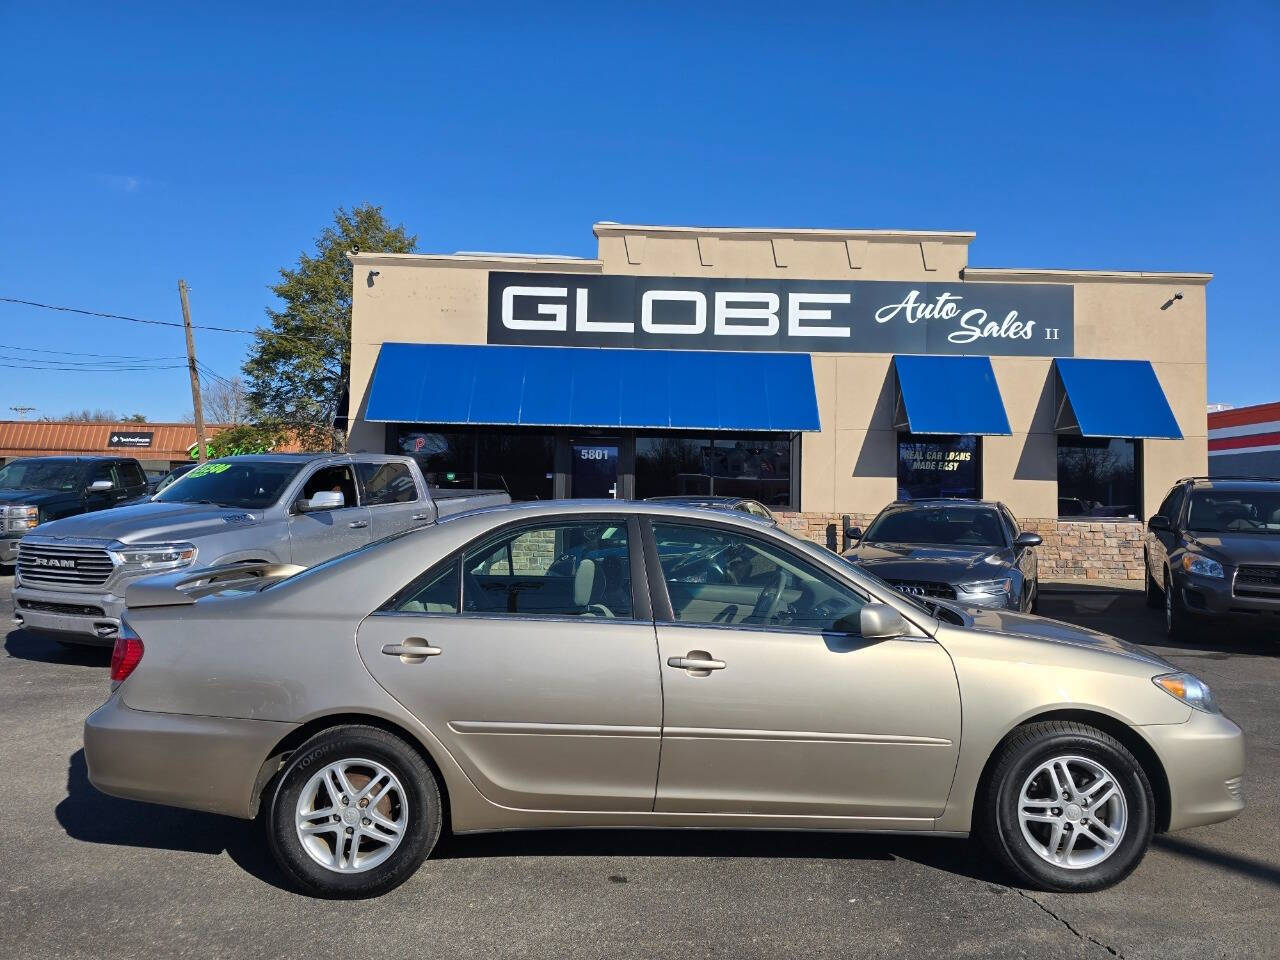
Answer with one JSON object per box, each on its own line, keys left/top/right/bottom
{"left": 54, "top": 750, "right": 289, "bottom": 890}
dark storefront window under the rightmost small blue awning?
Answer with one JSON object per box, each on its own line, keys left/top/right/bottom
{"left": 1057, "top": 436, "right": 1139, "bottom": 520}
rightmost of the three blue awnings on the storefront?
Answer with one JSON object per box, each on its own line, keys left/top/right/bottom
{"left": 1053, "top": 357, "right": 1183, "bottom": 440}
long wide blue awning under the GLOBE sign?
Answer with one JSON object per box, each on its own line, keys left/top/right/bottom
{"left": 365, "top": 343, "right": 820, "bottom": 431}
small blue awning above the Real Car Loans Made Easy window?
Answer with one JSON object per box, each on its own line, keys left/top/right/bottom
{"left": 893, "top": 356, "right": 1011, "bottom": 435}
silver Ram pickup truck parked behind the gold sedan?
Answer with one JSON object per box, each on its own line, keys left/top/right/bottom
{"left": 13, "top": 453, "right": 511, "bottom": 645}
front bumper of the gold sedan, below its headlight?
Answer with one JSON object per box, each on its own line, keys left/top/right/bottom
{"left": 1139, "top": 710, "right": 1244, "bottom": 829}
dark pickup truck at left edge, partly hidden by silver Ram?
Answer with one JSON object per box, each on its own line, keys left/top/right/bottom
{"left": 0, "top": 457, "right": 147, "bottom": 563}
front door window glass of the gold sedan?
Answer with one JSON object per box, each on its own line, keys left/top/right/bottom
{"left": 653, "top": 524, "right": 867, "bottom": 634}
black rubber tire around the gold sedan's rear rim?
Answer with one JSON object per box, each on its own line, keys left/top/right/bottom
{"left": 265, "top": 726, "right": 442, "bottom": 899}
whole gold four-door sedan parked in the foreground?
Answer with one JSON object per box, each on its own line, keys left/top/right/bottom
{"left": 84, "top": 500, "right": 1244, "bottom": 896}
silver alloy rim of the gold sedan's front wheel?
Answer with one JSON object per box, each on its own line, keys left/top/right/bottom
{"left": 1018, "top": 755, "right": 1129, "bottom": 870}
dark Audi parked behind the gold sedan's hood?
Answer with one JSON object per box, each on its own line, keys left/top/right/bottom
{"left": 845, "top": 499, "right": 1041, "bottom": 612}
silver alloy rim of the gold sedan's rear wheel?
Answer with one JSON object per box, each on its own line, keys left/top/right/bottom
{"left": 294, "top": 758, "right": 408, "bottom": 873}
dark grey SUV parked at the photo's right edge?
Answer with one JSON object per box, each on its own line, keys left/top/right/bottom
{"left": 1143, "top": 477, "right": 1280, "bottom": 639}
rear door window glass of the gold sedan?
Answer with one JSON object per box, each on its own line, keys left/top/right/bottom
{"left": 462, "top": 521, "right": 631, "bottom": 620}
